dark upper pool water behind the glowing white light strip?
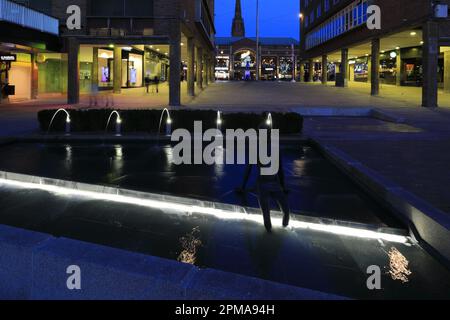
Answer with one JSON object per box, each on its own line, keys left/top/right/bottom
{"left": 0, "top": 143, "right": 401, "bottom": 227}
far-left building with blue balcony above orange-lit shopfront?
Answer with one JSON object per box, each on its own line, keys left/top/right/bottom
{"left": 0, "top": 0, "right": 59, "bottom": 103}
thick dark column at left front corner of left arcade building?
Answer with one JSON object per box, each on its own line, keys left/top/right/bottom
{"left": 67, "top": 38, "right": 80, "bottom": 104}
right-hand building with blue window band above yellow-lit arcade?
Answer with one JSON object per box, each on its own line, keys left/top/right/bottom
{"left": 300, "top": 0, "right": 450, "bottom": 107}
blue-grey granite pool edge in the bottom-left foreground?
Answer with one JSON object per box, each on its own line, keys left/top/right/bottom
{"left": 0, "top": 225, "right": 348, "bottom": 300}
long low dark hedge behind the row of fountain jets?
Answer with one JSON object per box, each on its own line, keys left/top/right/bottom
{"left": 38, "top": 109, "right": 303, "bottom": 134}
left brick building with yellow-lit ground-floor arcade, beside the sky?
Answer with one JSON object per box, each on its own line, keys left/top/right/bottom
{"left": 0, "top": 0, "right": 215, "bottom": 106}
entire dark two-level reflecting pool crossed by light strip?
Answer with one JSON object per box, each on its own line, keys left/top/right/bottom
{"left": 0, "top": 143, "right": 450, "bottom": 299}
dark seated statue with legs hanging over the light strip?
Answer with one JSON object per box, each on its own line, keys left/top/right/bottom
{"left": 236, "top": 123, "right": 290, "bottom": 233}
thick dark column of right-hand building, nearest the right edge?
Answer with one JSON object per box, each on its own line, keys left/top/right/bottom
{"left": 422, "top": 21, "right": 439, "bottom": 108}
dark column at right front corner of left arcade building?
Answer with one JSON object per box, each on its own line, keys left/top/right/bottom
{"left": 169, "top": 36, "right": 181, "bottom": 107}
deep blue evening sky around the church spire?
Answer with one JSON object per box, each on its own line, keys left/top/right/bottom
{"left": 215, "top": 0, "right": 300, "bottom": 40}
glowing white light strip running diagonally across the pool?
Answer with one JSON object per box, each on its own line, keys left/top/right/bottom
{"left": 0, "top": 178, "right": 410, "bottom": 244}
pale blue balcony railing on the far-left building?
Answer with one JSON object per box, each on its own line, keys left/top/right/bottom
{"left": 0, "top": 0, "right": 59, "bottom": 35}
